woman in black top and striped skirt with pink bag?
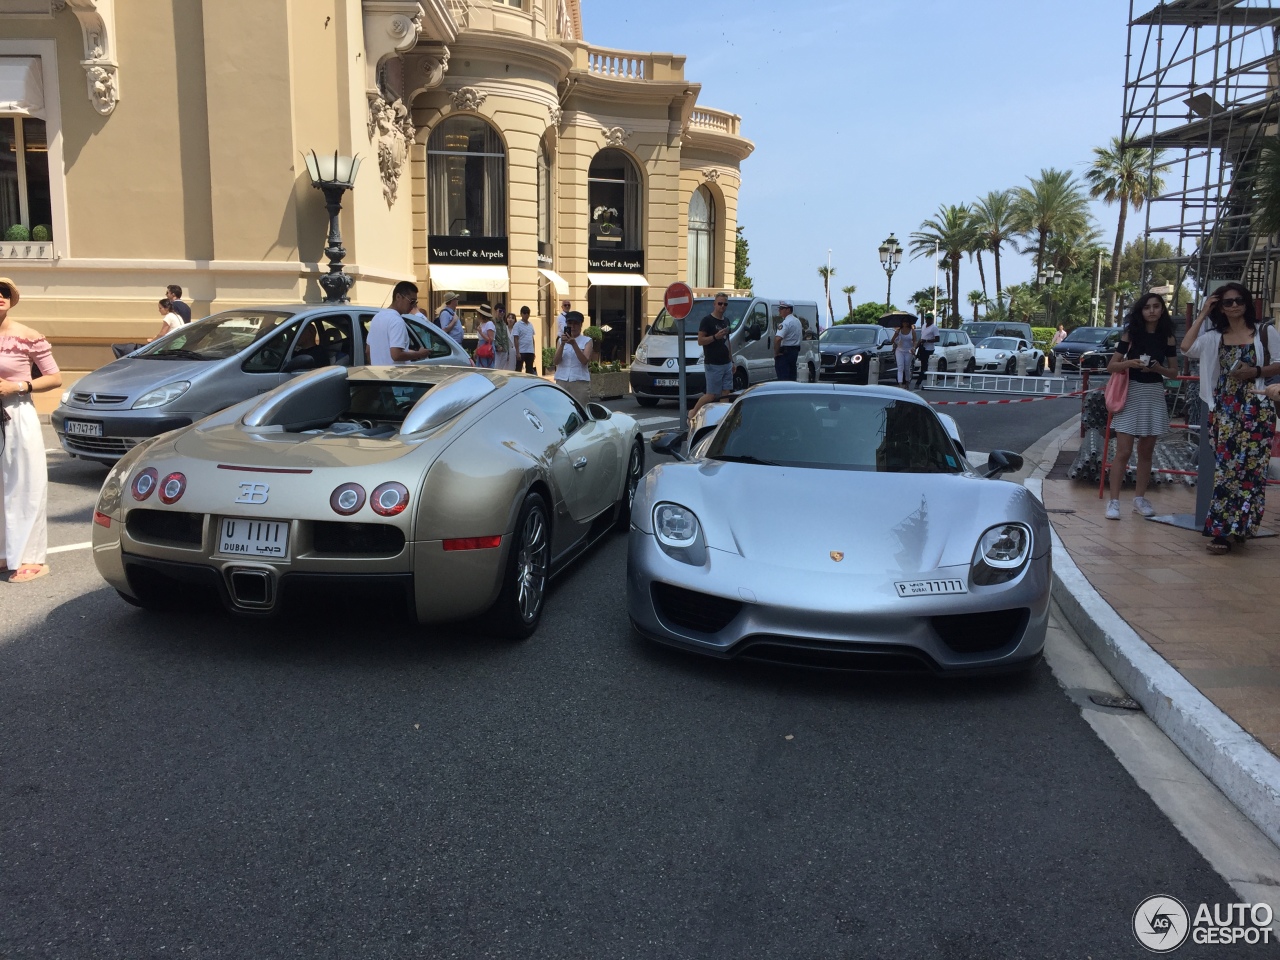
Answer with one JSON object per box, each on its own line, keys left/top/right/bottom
{"left": 1107, "top": 293, "right": 1178, "bottom": 520}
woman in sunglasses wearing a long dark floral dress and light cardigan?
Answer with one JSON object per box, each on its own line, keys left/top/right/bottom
{"left": 1181, "top": 283, "right": 1280, "bottom": 554}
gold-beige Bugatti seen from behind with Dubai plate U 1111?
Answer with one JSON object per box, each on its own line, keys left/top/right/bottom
{"left": 93, "top": 366, "right": 644, "bottom": 637}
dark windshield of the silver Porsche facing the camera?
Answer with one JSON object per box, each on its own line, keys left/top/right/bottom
{"left": 707, "top": 393, "right": 963, "bottom": 474}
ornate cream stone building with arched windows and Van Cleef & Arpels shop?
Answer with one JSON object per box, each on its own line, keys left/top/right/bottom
{"left": 0, "top": 0, "right": 753, "bottom": 369}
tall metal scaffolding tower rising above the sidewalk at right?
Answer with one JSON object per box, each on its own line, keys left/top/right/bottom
{"left": 1121, "top": 0, "right": 1280, "bottom": 314}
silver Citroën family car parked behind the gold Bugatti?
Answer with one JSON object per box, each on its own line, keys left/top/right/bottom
{"left": 50, "top": 303, "right": 471, "bottom": 463}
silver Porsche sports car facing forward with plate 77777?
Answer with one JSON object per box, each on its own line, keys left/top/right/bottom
{"left": 627, "top": 384, "right": 1051, "bottom": 673}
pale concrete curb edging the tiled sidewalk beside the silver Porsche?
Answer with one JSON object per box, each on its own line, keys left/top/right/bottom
{"left": 1023, "top": 448, "right": 1280, "bottom": 846}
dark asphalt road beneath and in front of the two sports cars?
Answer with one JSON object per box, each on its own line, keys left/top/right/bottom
{"left": 0, "top": 404, "right": 1259, "bottom": 960}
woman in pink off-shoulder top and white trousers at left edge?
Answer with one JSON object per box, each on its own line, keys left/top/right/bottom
{"left": 0, "top": 276, "right": 63, "bottom": 584}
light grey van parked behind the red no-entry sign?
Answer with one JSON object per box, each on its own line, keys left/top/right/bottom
{"left": 631, "top": 297, "right": 822, "bottom": 407}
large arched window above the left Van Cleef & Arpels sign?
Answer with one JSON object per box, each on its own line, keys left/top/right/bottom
{"left": 426, "top": 116, "right": 507, "bottom": 237}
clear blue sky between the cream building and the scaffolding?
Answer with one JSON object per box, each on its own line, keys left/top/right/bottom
{"left": 582, "top": 0, "right": 1131, "bottom": 314}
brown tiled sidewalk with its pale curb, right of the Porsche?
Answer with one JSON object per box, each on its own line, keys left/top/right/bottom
{"left": 1025, "top": 419, "right": 1280, "bottom": 846}
